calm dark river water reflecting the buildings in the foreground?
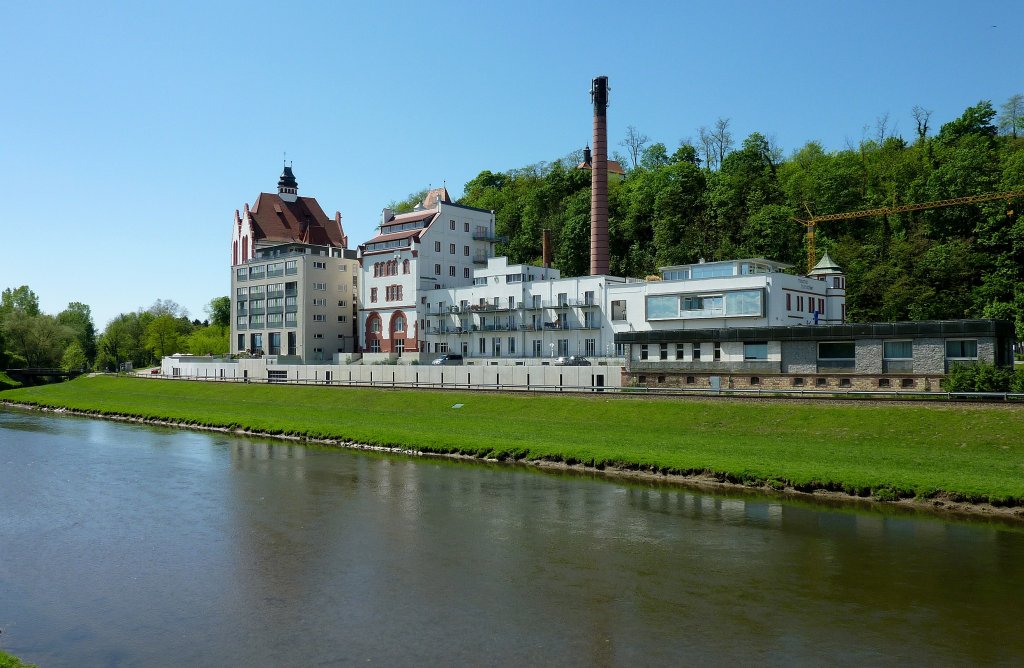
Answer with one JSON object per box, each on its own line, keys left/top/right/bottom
{"left": 0, "top": 409, "right": 1024, "bottom": 667}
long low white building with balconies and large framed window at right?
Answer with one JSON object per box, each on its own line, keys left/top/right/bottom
{"left": 411, "top": 257, "right": 846, "bottom": 364}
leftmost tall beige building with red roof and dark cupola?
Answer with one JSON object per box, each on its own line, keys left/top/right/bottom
{"left": 230, "top": 166, "right": 358, "bottom": 363}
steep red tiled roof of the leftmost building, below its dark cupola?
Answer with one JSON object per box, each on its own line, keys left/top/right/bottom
{"left": 249, "top": 193, "right": 344, "bottom": 248}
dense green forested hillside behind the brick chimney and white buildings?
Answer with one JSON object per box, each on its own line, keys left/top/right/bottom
{"left": 461, "top": 95, "right": 1024, "bottom": 338}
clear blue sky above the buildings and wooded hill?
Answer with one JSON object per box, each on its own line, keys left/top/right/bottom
{"left": 0, "top": 0, "right": 1024, "bottom": 330}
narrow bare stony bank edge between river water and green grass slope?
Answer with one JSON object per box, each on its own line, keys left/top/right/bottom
{"left": 8, "top": 400, "right": 1024, "bottom": 523}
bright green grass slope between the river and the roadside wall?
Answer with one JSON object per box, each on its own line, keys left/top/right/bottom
{"left": 0, "top": 377, "right": 1024, "bottom": 505}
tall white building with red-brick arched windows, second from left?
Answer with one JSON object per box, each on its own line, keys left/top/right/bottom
{"left": 359, "top": 187, "right": 499, "bottom": 361}
